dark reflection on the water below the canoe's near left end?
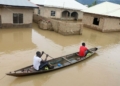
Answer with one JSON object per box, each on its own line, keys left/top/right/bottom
{"left": 10, "top": 73, "right": 52, "bottom": 86}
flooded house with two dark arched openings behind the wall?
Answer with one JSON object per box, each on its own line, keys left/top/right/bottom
{"left": 31, "top": 0, "right": 87, "bottom": 20}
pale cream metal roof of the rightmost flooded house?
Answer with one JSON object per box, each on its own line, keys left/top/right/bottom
{"left": 83, "top": 2, "right": 120, "bottom": 17}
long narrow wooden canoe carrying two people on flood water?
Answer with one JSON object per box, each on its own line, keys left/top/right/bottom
{"left": 7, "top": 48, "right": 97, "bottom": 77}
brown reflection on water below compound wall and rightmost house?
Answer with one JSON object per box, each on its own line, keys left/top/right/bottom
{"left": 34, "top": 22, "right": 120, "bottom": 47}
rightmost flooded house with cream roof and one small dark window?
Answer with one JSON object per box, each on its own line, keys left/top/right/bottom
{"left": 83, "top": 2, "right": 120, "bottom": 32}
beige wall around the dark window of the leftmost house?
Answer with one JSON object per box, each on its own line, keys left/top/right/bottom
{"left": 0, "top": 7, "right": 33, "bottom": 24}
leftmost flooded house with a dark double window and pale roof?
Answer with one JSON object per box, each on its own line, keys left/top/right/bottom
{"left": 0, "top": 0, "right": 37, "bottom": 28}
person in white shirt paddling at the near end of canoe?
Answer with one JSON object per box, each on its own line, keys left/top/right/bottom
{"left": 33, "top": 51, "right": 48, "bottom": 70}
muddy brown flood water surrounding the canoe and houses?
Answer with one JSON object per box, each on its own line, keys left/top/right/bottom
{"left": 0, "top": 23, "right": 120, "bottom": 86}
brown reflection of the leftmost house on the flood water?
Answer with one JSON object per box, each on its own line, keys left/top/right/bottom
{"left": 0, "top": 28, "right": 36, "bottom": 52}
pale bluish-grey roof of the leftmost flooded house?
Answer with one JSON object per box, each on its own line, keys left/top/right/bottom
{"left": 0, "top": 0, "right": 37, "bottom": 7}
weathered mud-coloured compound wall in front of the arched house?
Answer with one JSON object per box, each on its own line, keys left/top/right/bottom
{"left": 33, "top": 15, "right": 83, "bottom": 35}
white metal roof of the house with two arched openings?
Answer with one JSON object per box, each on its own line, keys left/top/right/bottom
{"left": 31, "top": 0, "right": 88, "bottom": 10}
